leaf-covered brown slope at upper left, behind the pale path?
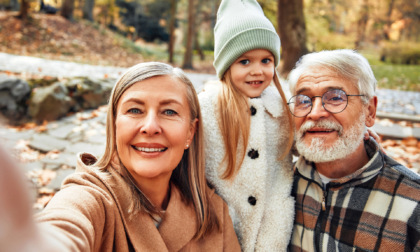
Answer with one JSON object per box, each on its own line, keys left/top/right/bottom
{"left": 0, "top": 11, "right": 149, "bottom": 67}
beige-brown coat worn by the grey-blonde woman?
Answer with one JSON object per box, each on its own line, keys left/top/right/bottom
{"left": 37, "top": 154, "right": 240, "bottom": 252}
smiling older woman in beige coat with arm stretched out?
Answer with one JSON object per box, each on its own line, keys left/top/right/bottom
{"left": 0, "top": 62, "right": 240, "bottom": 251}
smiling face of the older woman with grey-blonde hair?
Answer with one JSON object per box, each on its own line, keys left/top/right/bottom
{"left": 115, "top": 76, "right": 197, "bottom": 185}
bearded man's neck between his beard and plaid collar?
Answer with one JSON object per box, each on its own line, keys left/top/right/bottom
{"left": 315, "top": 142, "right": 369, "bottom": 179}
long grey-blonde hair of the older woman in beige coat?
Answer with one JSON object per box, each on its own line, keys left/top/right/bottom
{"left": 95, "top": 62, "right": 220, "bottom": 239}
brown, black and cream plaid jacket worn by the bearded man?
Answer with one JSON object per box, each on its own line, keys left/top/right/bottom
{"left": 289, "top": 139, "right": 420, "bottom": 251}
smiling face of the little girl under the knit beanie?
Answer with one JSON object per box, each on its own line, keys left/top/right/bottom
{"left": 230, "top": 49, "right": 275, "bottom": 98}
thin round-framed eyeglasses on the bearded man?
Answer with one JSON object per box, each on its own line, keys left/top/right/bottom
{"left": 287, "top": 89, "right": 365, "bottom": 117}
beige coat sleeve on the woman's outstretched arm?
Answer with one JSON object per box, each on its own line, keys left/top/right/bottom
{"left": 36, "top": 176, "right": 109, "bottom": 251}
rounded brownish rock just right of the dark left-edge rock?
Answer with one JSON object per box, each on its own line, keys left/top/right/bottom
{"left": 29, "top": 82, "right": 74, "bottom": 122}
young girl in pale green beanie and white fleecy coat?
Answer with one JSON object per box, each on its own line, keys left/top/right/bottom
{"left": 199, "top": 0, "right": 294, "bottom": 251}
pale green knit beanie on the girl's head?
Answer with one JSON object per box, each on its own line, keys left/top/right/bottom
{"left": 213, "top": 0, "right": 280, "bottom": 79}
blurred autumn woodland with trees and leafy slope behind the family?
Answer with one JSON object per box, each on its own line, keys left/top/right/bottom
{"left": 0, "top": 0, "right": 420, "bottom": 91}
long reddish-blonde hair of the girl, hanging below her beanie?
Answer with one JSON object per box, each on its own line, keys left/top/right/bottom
{"left": 218, "top": 68, "right": 294, "bottom": 179}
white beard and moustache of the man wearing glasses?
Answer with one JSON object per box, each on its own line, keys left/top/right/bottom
{"left": 296, "top": 113, "right": 366, "bottom": 163}
